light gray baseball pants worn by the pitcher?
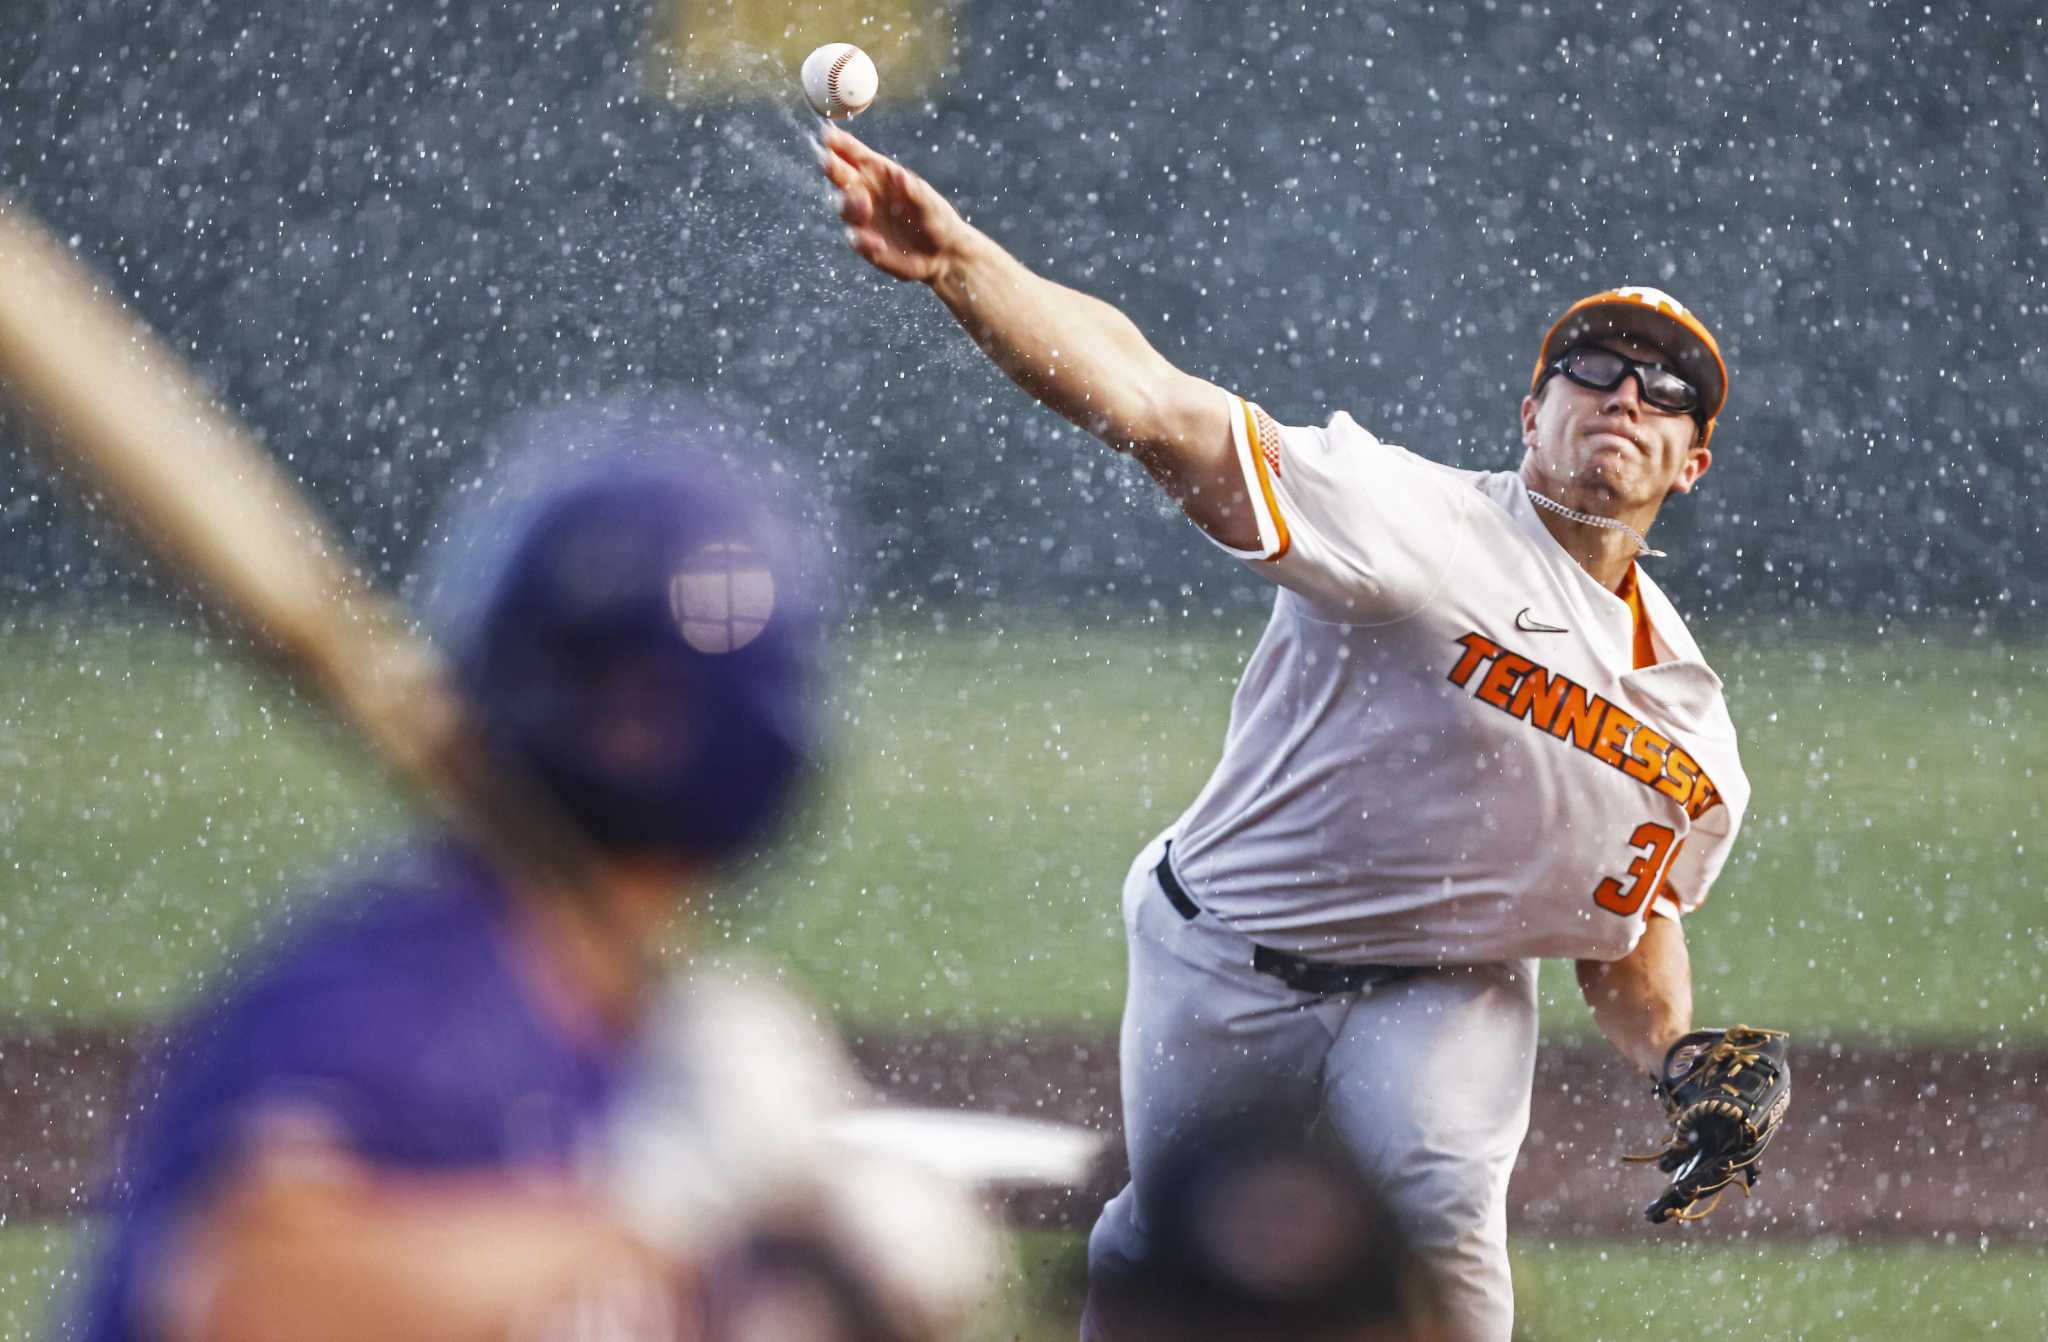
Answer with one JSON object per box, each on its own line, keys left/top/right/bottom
{"left": 1083, "top": 838, "right": 1536, "bottom": 1342}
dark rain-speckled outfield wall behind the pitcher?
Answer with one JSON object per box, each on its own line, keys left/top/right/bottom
{"left": 0, "top": 0, "right": 2048, "bottom": 627}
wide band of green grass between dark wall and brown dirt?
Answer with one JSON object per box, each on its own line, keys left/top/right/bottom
{"left": 0, "top": 617, "right": 2048, "bottom": 1043}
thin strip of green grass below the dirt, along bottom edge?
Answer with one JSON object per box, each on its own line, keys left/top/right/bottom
{"left": 12, "top": 1225, "right": 2048, "bottom": 1342}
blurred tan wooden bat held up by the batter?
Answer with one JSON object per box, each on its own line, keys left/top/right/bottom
{"left": 0, "top": 197, "right": 645, "bottom": 1000}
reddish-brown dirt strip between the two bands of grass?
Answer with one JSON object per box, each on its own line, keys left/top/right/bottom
{"left": 0, "top": 1031, "right": 2048, "bottom": 1242}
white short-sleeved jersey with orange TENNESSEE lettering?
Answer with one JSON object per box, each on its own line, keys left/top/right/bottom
{"left": 1174, "top": 395, "right": 1749, "bottom": 965}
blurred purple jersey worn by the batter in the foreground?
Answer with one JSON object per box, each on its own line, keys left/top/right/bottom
{"left": 70, "top": 844, "right": 625, "bottom": 1342}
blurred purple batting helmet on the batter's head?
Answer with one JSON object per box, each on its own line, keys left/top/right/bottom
{"left": 438, "top": 404, "right": 819, "bottom": 858}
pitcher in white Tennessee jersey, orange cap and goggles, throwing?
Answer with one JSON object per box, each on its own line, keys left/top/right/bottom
{"left": 819, "top": 129, "right": 1788, "bottom": 1342}
